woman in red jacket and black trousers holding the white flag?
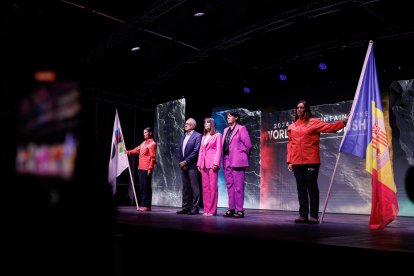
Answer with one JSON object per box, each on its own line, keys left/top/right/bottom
{"left": 126, "top": 127, "right": 157, "bottom": 212}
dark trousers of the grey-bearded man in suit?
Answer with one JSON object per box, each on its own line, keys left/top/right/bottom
{"left": 182, "top": 170, "right": 200, "bottom": 210}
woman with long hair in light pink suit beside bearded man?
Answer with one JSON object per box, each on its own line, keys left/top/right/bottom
{"left": 197, "top": 118, "right": 222, "bottom": 216}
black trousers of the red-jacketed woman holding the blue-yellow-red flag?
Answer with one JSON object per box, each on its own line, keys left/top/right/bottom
{"left": 293, "top": 164, "right": 320, "bottom": 218}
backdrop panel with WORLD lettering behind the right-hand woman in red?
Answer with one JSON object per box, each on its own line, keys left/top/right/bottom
{"left": 260, "top": 101, "right": 371, "bottom": 214}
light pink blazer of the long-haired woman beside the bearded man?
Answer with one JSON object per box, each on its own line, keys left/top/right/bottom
{"left": 197, "top": 132, "right": 223, "bottom": 169}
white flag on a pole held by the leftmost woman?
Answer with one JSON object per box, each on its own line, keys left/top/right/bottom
{"left": 108, "top": 110, "right": 129, "bottom": 194}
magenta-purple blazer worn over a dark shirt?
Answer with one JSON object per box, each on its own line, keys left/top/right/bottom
{"left": 223, "top": 124, "right": 252, "bottom": 168}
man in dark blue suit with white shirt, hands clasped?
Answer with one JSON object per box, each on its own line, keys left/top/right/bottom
{"left": 177, "top": 118, "right": 202, "bottom": 215}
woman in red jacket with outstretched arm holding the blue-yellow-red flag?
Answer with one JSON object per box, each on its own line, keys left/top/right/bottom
{"left": 287, "top": 101, "right": 348, "bottom": 224}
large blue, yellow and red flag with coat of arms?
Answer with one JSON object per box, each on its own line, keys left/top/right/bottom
{"left": 339, "top": 41, "right": 398, "bottom": 229}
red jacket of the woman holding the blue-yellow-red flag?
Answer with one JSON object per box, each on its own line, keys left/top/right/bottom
{"left": 286, "top": 118, "right": 345, "bottom": 165}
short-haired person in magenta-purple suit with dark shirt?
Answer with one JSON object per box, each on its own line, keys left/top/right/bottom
{"left": 223, "top": 110, "right": 252, "bottom": 218}
